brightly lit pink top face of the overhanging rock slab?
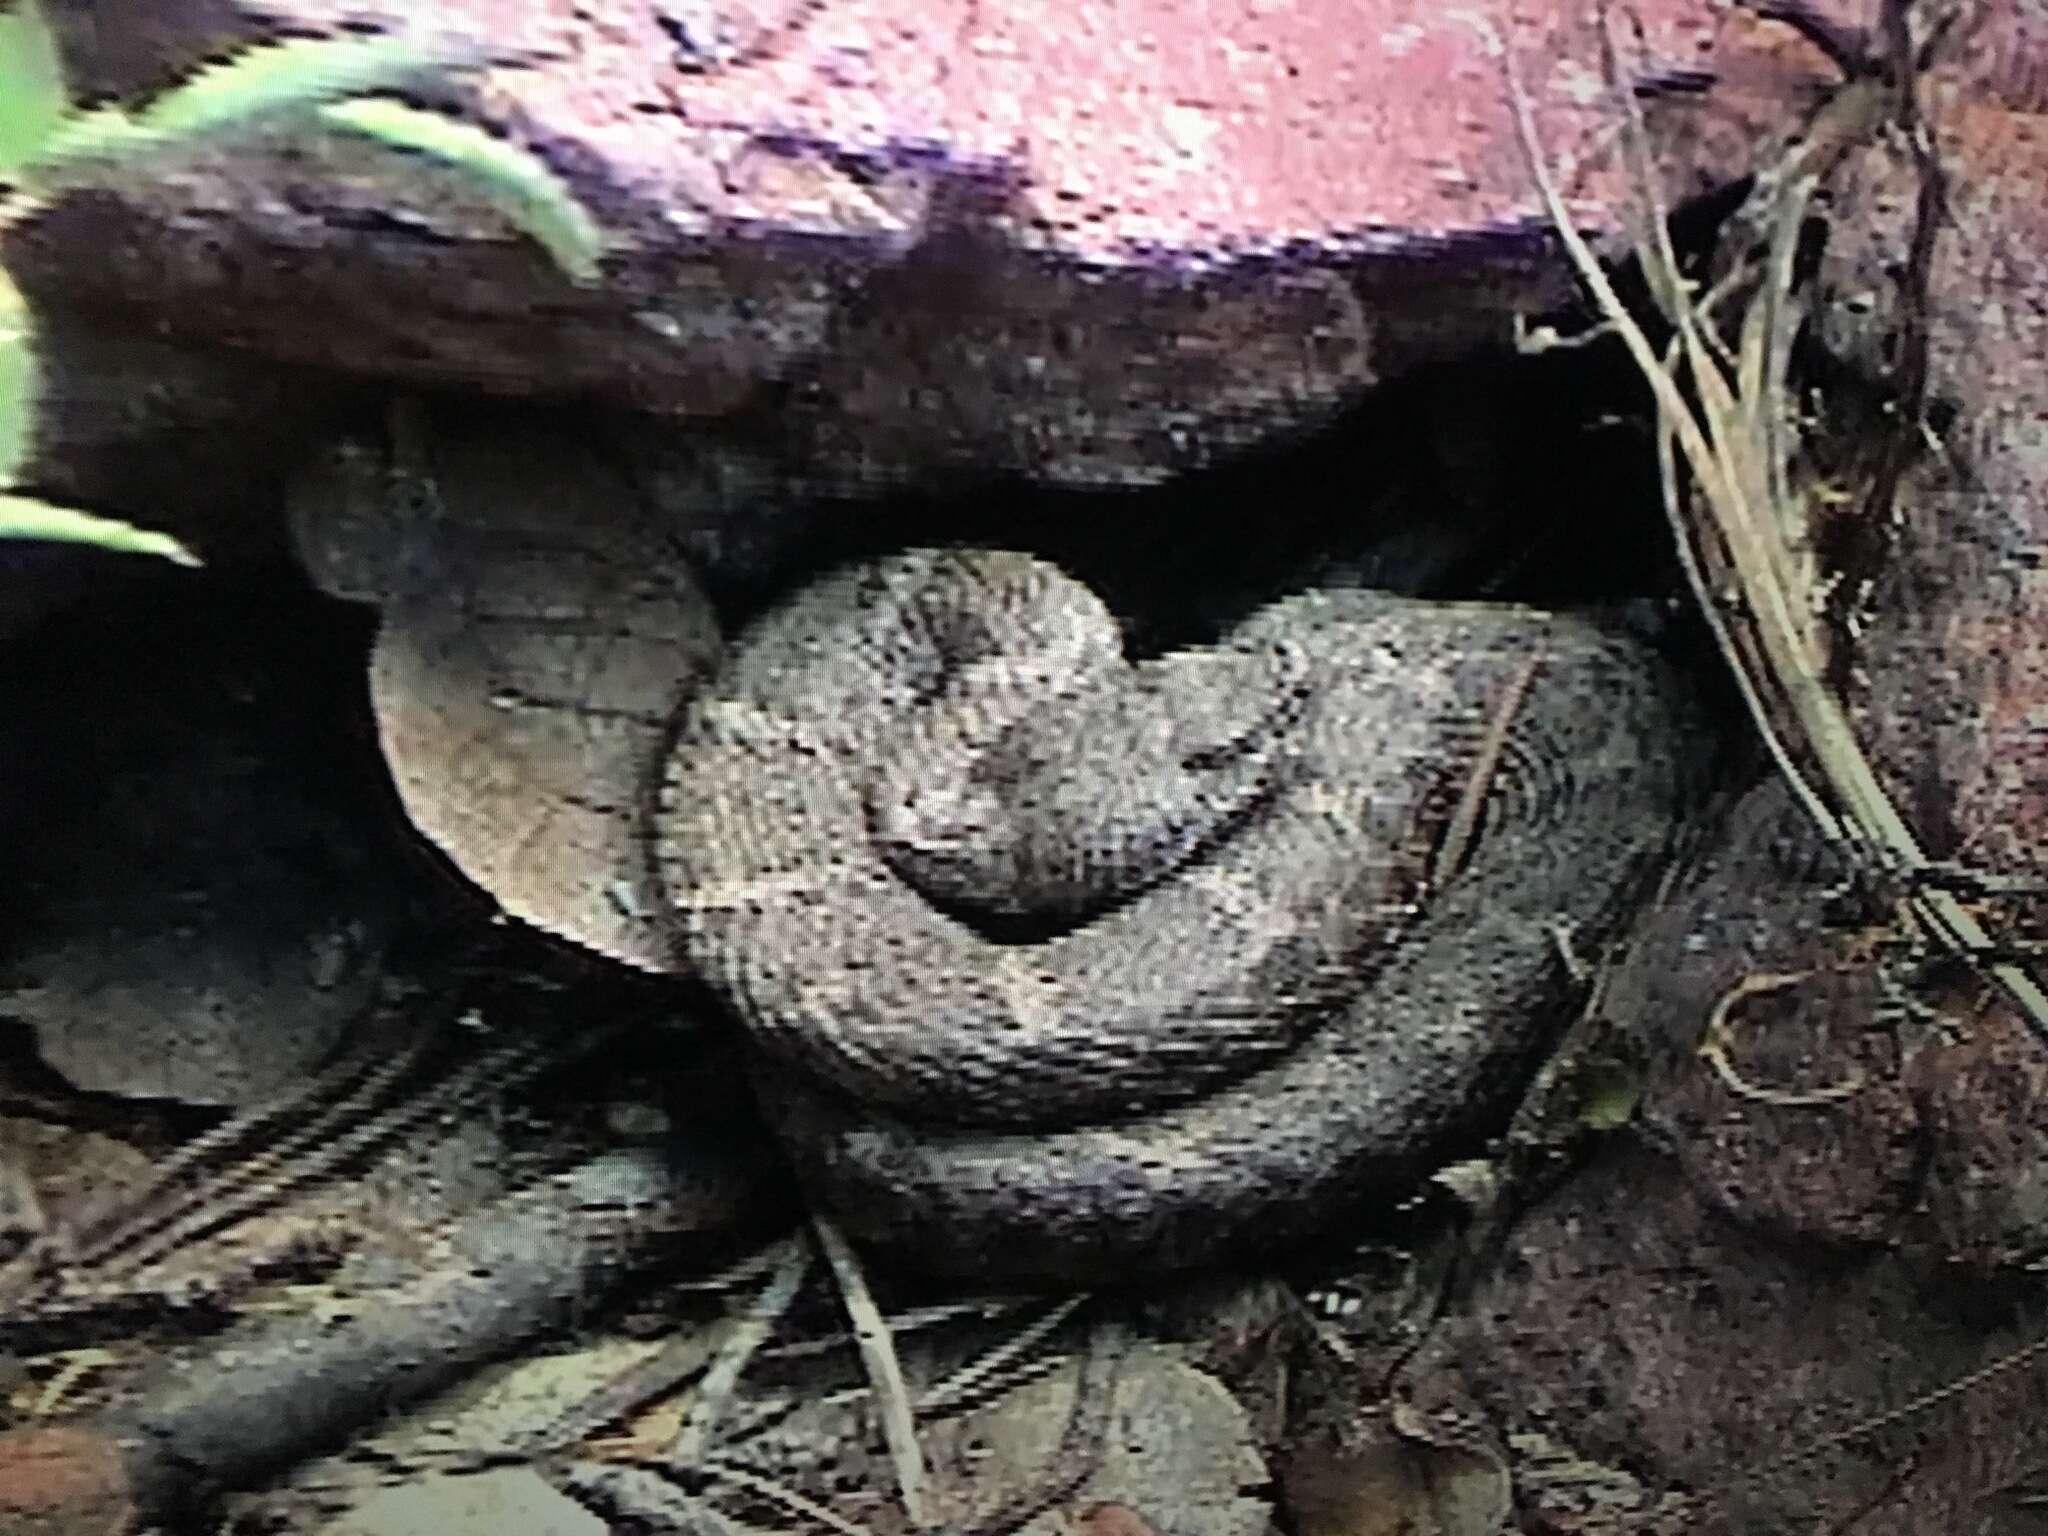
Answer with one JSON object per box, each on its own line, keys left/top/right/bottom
{"left": 256, "top": 0, "right": 1794, "bottom": 266}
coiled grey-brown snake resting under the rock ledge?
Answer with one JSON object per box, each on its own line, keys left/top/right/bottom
{"left": 651, "top": 551, "right": 1700, "bottom": 1280}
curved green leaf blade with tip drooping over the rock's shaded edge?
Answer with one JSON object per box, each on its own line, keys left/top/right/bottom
{"left": 319, "top": 96, "right": 604, "bottom": 283}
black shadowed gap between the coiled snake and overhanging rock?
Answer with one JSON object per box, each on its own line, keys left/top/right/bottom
{"left": 671, "top": 331, "right": 1677, "bottom": 651}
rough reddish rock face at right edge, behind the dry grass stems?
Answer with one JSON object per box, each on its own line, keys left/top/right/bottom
{"left": 1823, "top": 6, "right": 2048, "bottom": 876}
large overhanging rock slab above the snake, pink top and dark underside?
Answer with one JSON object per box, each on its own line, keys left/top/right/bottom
{"left": 14, "top": 0, "right": 1829, "bottom": 493}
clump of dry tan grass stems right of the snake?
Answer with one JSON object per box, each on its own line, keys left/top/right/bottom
{"left": 1493, "top": 12, "right": 2048, "bottom": 1038}
